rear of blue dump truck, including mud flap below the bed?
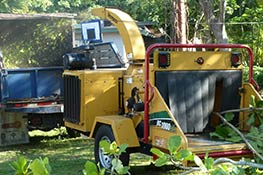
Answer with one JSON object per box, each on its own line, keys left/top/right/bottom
{"left": 0, "top": 67, "right": 63, "bottom": 146}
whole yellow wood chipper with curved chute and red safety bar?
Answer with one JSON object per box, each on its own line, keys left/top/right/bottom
{"left": 63, "top": 8, "right": 261, "bottom": 168}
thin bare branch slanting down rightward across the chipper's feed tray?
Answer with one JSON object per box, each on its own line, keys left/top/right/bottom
{"left": 214, "top": 109, "right": 263, "bottom": 161}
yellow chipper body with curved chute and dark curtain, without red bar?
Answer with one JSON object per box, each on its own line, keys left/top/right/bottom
{"left": 64, "top": 8, "right": 261, "bottom": 160}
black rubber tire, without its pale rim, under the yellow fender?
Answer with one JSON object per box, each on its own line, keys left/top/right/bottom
{"left": 94, "top": 125, "right": 130, "bottom": 169}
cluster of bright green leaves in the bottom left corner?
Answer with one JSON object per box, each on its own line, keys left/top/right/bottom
{"left": 10, "top": 156, "right": 51, "bottom": 175}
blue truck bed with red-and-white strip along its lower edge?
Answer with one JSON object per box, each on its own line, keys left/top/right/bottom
{"left": 0, "top": 67, "right": 63, "bottom": 113}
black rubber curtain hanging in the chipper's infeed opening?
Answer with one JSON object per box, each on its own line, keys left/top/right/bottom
{"left": 155, "top": 70, "right": 242, "bottom": 133}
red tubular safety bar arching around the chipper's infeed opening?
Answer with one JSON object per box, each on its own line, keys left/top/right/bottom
{"left": 143, "top": 44, "right": 259, "bottom": 143}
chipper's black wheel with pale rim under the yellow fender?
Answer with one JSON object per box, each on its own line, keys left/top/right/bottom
{"left": 94, "top": 125, "right": 130, "bottom": 169}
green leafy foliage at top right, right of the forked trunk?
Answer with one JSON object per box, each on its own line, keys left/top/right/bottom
{"left": 226, "top": 0, "right": 263, "bottom": 65}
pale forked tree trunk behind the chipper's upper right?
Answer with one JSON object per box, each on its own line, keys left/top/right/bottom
{"left": 199, "top": 0, "right": 228, "bottom": 43}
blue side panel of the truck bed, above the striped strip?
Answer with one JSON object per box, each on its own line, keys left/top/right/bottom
{"left": 1, "top": 67, "right": 63, "bottom": 103}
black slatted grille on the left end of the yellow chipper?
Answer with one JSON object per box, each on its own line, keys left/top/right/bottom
{"left": 63, "top": 75, "right": 81, "bottom": 124}
